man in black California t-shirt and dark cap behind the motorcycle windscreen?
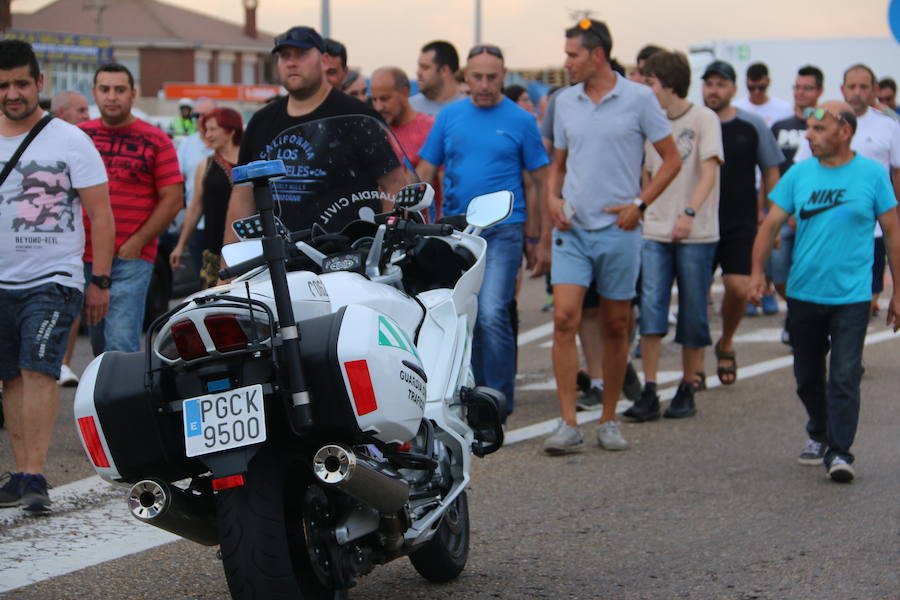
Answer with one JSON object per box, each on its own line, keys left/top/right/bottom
{"left": 224, "top": 27, "right": 410, "bottom": 244}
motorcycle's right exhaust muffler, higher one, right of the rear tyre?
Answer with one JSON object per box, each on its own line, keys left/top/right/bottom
{"left": 313, "top": 444, "right": 409, "bottom": 513}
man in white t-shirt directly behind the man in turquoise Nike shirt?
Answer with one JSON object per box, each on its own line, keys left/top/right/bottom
{"left": 794, "top": 64, "right": 900, "bottom": 313}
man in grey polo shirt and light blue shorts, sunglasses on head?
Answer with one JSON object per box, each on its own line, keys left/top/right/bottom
{"left": 540, "top": 19, "right": 681, "bottom": 454}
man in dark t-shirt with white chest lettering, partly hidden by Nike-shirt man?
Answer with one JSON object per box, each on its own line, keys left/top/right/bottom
{"left": 766, "top": 65, "right": 824, "bottom": 345}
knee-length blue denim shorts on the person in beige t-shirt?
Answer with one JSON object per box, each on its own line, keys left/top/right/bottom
{"left": 640, "top": 240, "right": 716, "bottom": 348}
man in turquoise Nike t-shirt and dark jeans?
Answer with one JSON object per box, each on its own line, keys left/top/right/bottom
{"left": 749, "top": 102, "right": 900, "bottom": 482}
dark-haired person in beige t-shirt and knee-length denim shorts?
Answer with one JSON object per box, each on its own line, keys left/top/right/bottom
{"left": 625, "top": 50, "right": 724, "bottom": 421}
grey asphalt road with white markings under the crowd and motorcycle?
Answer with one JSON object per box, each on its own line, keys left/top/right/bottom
{"left": 0, "top": 282, "right": 900, "bottom": 600}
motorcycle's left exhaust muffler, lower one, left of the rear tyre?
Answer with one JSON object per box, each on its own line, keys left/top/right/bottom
{"left": 128, "top": 479, "right": 219, "bottom": 546}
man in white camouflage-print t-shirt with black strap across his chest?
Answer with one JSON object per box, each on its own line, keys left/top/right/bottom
{"left": 0, "top": 39, "right": 114, "bottom": 514}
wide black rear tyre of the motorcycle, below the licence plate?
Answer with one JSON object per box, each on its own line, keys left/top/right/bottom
{"left": 216, "top": 447, "right": 335, "bottom": 600}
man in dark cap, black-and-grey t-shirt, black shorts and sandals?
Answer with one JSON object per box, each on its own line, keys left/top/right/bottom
{"left": 703, "top": 60, "right": 784, "bottom": 385}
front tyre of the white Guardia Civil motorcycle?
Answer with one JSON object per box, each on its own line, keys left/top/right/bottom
{"left": 409, "top": 492, "right": 469, "bottom": 583}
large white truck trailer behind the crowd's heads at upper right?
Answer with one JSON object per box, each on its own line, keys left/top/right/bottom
{"left": 688, "top": 37, "right": 900, "bottom": 104}
